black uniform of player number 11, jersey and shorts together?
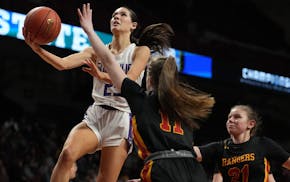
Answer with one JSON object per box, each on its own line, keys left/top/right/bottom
{"left": 121, "top": 78, "right": 208, "bottom": 182}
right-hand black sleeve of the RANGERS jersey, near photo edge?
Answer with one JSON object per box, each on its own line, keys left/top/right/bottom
{"left": 261, "top": 137, "right": 290, "bottom": 165}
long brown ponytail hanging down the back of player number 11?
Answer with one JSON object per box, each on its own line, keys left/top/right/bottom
{"left": 148, "top": 56, "right": 215, "bottom": 129}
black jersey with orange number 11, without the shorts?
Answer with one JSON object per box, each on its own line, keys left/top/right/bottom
{"left": 121, "top": 78, "right": 193, "bottom": 159}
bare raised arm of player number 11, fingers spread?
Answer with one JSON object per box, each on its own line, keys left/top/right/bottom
{"left": 78, "top": 3, "right": 126, "bottom": 89}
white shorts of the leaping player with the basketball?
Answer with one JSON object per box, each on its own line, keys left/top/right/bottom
{"left": 83, "top": 104, "right": 132, "bottom": 151}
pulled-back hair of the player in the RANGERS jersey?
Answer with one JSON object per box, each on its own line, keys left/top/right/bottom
{"left": 231, "top": 104, "right": 262, "bottom": 136}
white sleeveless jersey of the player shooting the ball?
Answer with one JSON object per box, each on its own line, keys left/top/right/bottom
{"left": 92, "top": 43, "right": 144, "bottom": 113}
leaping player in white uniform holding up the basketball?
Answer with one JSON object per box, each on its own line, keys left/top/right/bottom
{"left": 23, "top": 3, "right": 172, "bottom": 182}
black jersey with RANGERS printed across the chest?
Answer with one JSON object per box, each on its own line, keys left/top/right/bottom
{"left": 199, "top": 136, "right": 289, "bottom": 182}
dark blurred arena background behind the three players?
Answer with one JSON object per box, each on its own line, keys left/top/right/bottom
{"left": 0, "top": 0, "right": 290, "bottom": 182}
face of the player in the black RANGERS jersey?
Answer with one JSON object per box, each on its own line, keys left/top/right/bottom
{"left": 226, "top": 107, "right": 252, "bottom": 136}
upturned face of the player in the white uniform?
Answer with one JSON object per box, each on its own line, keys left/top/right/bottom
{"left": 110, "top": 7, "right": 137, "bottom": 34}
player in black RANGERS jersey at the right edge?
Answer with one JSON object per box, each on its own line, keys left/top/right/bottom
{"left": 193, "top": 105, "right": 290, "bottom": 182}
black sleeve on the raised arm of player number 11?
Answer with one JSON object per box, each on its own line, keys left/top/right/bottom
{"left": 121, "top": 78, "right": 146, "bottom": 114}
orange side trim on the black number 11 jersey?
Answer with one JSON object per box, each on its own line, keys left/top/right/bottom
{"left": 132, "top": 116, "right": 150, "bottom": 160}
